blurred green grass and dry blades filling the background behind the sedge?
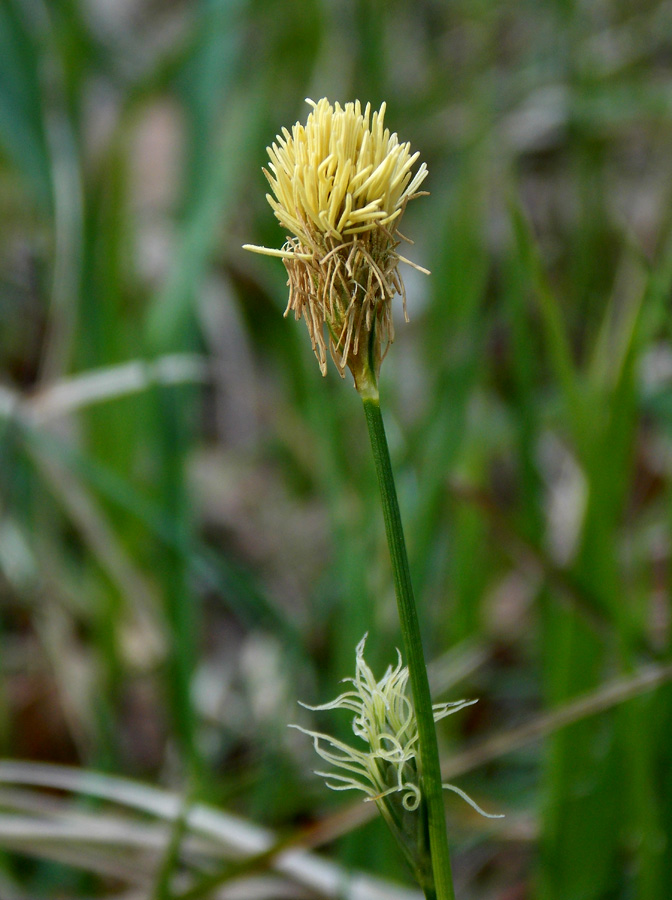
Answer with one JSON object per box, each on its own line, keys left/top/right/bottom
{"left": 0, "top": 0, "right": 672, "bottom": 900}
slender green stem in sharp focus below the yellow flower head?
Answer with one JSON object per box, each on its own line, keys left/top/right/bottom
{"left": 360, "top": 394, "right": 455, "bottom": 900}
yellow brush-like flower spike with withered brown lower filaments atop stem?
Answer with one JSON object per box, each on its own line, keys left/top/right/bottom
{"left": 245, "top": 98, "right": 427, "bottom": 393}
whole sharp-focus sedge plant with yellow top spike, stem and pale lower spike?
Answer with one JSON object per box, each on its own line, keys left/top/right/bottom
{"left": 245, "top": 98, "right": 498, "bottom": 900}
